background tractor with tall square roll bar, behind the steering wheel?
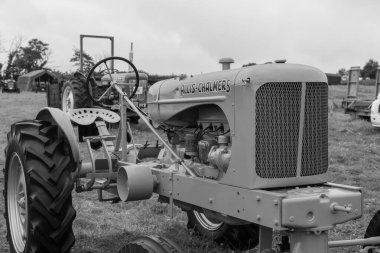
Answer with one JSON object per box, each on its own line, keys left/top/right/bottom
{"left": 47, "top": 35, "right": 148, "bottom": 123}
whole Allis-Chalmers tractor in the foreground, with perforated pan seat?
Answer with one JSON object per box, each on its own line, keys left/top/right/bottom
{"left": 5, "top": 57, "right": 380, "bottom": 253}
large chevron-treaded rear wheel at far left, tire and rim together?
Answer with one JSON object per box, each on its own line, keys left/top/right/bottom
{"left": 4, "top": 120, "right": 76, "bottom": 253}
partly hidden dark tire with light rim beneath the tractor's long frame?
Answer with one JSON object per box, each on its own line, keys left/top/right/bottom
{"left": 187, "top": 210, "right": 259, "bottom": 250}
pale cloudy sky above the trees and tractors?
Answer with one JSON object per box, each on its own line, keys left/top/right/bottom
{"left": 0, "top": 0, "right": 380, "bottom": 74}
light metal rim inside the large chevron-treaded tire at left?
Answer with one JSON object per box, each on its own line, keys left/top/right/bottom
{"left": 7, "top": 153, "right": 28, "bottom": 252}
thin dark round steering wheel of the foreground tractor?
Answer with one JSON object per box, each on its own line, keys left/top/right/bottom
{"left": 86, "top": 57, "right": 140, "bottom": 108}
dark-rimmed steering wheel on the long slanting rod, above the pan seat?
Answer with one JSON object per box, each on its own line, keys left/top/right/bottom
{"left": 86, "top": 57, "right": 139, "bottom": 108}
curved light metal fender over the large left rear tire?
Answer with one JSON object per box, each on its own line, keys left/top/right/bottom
{"left": 36, "top": 107, "right": 79, "bottom": 164}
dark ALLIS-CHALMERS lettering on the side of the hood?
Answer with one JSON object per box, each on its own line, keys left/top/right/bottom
{"left": 181, "top": 79, "right": 231, "bottom": 96}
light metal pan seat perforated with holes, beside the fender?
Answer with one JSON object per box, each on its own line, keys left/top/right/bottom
{"left": 70, "top": 108, "right": 120, "bottom": 125}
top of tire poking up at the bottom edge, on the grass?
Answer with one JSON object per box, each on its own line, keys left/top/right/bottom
{"left": 118, "top": 236, "right": 183, "bottom": 253}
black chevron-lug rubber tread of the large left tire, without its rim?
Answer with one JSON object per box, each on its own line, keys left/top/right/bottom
{"left": 4, "top": 120, "right": 76, "bottom": 253}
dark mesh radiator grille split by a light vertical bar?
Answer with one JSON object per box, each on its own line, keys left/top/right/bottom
{"left": 255, "top": 83, "right": 328, "bottom": 178}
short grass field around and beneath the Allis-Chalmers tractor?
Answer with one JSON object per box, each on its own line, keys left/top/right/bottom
{"left": 0, "top": 86, "right": 380, "bottom": 253}
